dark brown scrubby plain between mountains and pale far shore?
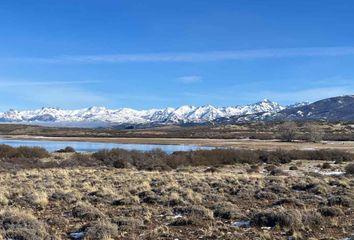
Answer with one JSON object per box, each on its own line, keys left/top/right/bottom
{"left": 0, "top": 122, "right": 354, "bottom": 141}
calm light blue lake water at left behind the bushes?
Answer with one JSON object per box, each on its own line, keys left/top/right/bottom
{"left": 0, "top": 139, "right": 212, "bottom": 153}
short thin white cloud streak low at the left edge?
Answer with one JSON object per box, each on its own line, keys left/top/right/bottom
{"left": 0, "top": 80, "right": 98, "bottom": 87}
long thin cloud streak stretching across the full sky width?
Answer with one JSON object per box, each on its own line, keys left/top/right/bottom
{"left": 5, "top": 47, "right": 354, "bottom": 64}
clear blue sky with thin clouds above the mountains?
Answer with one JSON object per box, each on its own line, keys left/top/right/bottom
{"left": 0, "top": 0, "right": 354, "bottom": 111}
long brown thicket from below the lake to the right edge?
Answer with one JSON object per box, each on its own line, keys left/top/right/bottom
{"left": 92, "top": 148, "right": 353, "bottom": 172}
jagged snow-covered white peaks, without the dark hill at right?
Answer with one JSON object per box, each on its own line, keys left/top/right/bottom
{"left": 0, "top": 99, "right": 302, "bottom": 126}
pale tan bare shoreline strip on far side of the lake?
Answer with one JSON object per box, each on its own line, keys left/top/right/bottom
{"left": 0, "top": 135, "right": 354, "bottom": 152}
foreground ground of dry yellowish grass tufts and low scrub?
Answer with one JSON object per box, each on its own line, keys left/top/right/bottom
{"left": 0, "top": 153, "right": 354, "bottom": 239}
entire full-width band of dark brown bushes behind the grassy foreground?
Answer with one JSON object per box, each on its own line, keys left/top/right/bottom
{"left": 0, "top": 145, "right": 348, "bottom": 173}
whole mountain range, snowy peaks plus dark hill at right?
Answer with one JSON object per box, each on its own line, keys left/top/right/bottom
{"left": 0, "top": 96, "right": 354, "bottom": 127}
